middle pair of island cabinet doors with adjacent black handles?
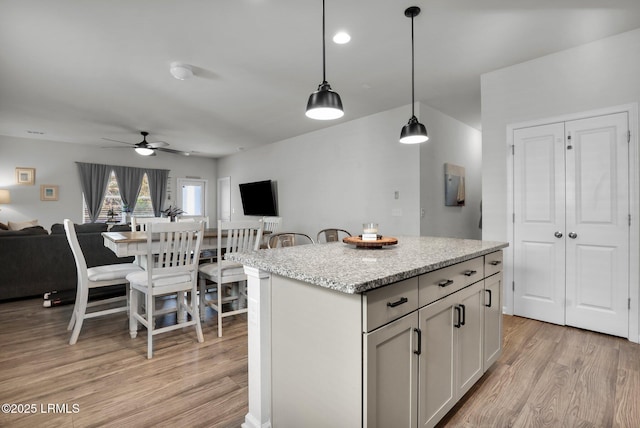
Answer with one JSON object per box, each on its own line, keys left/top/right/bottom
{"left": 418, "top": 281, "right": 484, "bottom": 427}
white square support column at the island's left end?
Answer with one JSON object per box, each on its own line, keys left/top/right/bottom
{"left": 242, "top": 266, "right": 271, "bottom": 428}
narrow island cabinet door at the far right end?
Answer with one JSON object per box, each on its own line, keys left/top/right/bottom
{"left": 484, "top": 272, "right": 502, "bottom": 372}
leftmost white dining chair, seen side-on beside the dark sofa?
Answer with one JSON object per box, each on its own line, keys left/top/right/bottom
{"left": 64, "top": 219, "right": 142, "bottom": 345}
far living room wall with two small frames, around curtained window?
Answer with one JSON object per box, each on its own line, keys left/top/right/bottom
{"left": 0, "top": 136, "right": 217, "bottom": 230}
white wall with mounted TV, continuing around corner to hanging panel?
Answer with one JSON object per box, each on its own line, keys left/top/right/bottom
{"left": 218, "top": 101, "right": 480, "bottom": 239}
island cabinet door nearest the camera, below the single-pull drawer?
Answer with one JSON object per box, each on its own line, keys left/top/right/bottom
{"left": 364, "top": 312, "right": 424, "bottom": 428}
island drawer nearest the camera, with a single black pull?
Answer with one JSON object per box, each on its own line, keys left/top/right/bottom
{"left": 362, "top": 277, "right": 418, "bottom": 332}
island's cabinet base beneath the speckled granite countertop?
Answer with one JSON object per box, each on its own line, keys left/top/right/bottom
{"left": 268, "top": 252, "right": 502, "bottom": 428}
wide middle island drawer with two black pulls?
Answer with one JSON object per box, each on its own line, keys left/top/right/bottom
{"left": 419, "top": 257, "right": 484, "bottom": 307}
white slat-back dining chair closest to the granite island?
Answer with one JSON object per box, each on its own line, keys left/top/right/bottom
{"left": 199, "top": 220, "right": 263, "bottom": 337}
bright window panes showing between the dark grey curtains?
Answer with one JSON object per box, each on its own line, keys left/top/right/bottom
{"left": 82, "top": 171, "right": 155, "bottom": 223}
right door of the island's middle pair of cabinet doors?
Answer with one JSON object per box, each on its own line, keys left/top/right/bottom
{"left": 454, "top": 281, "right": 484, "bottom": 399}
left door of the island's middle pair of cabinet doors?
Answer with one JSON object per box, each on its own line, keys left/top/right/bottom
{"left": 418, "top": 293, "right": 458, "bottom": 427}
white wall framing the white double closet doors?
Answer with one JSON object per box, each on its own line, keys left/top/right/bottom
{"left": 481, "top": 29, "right": 640, "bottom": 340}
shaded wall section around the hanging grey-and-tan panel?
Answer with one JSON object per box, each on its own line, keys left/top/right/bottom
{"left": 420, "top": 104, "right": 482, "bottom": 239}
